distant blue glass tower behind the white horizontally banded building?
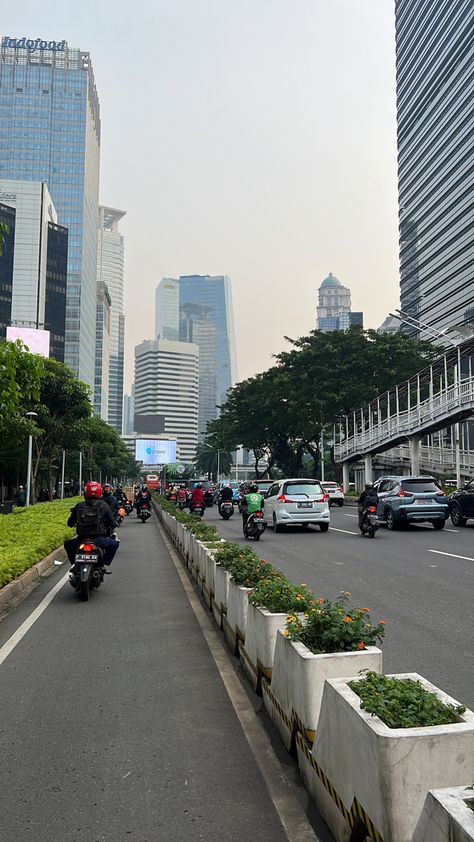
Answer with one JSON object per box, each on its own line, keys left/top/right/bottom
{"left": 179, "top": 275, "right": 237, "bottom": 430}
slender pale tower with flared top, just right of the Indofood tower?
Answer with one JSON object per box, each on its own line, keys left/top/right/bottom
{"left": 97, "top": 205, "right": 125, "bottom": 433}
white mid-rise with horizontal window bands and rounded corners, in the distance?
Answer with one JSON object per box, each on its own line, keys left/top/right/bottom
{"left": 135, "top": 339, "right": 199, "bottom": 462}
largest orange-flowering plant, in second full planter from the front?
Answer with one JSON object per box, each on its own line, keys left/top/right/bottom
{"left": 284, "top": 591, "right": 385, "bottom": 655}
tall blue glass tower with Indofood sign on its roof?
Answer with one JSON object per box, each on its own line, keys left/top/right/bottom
{"left": 0, "top": 36, "right": 100, "bottom": 387}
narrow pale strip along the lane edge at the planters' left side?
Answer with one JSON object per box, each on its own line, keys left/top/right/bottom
{"left": 157, "top": 521, "right": 321, "bottom": 842}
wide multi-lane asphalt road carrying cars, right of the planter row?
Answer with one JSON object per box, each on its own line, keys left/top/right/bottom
{"left": 205, "top": 506, "right": 474, "bottom": 709}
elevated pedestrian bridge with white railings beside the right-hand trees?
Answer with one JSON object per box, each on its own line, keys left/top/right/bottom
{"left": 334, "top": 338, "right": 474, "bottom": 479}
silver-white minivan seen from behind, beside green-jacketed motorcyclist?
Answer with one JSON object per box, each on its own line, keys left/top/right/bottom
{"left": 263, "top": 479, "right": 331, "bottom": 532}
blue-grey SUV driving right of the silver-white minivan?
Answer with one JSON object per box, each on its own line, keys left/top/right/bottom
{"left": 374, "top": 476, "right": 449, "bottom": 529}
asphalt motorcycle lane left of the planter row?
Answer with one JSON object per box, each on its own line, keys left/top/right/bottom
{"left": 0, "top": 517, "right": 287, "bottom": 842}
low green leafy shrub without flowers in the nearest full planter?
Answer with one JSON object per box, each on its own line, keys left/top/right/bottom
{"left": 349, "top": 672, "right": 466, "bottom": 728}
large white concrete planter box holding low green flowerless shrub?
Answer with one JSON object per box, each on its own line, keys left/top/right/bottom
{"left": 297, "top": 673, "right": 474, "bottom": 842}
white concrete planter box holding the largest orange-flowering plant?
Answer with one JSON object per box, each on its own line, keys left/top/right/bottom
{"left": 263, "top": 632, "right": 382, "bottom": 751}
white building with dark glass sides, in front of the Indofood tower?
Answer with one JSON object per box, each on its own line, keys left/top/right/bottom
{"left": 0, "top": 178, "right": 68, "bottom": 362}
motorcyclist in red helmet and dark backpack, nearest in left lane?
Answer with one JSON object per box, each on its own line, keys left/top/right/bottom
{"left": 64, "top": 482, "right": 120, "bottom": 572}
